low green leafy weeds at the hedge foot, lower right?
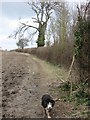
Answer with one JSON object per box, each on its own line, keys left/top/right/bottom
{"left": 58, "top": 82, "right": 90, "bottom": 106}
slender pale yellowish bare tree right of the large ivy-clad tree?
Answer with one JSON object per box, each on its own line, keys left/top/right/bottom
{"left": 51, "top": 2, "right": 69, "bottom": 48}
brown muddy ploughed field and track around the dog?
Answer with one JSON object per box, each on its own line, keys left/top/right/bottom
{"left": 2, "top": 52, "right": 71, "bottom": 118}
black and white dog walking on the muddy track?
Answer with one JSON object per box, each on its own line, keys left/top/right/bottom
{"left": 42, "top": 94, "right": 55, "bottom": 118}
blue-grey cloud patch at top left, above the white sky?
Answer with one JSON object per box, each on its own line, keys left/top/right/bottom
{"left": 2, "top": 2, "right": 33, "bottom": 19}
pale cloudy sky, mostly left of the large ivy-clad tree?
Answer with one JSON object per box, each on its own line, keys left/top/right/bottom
{"left": 0, "top": 0, "right": 85, "bottom": 50}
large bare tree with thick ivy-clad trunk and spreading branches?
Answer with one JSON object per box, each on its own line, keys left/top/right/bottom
{"left": 9, "top": 2, "right": 57, "bottom": 47}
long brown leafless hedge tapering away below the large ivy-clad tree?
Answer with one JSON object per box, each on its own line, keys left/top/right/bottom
{"left": 16, "top": 40, "right": 73, "bottom": 67}
